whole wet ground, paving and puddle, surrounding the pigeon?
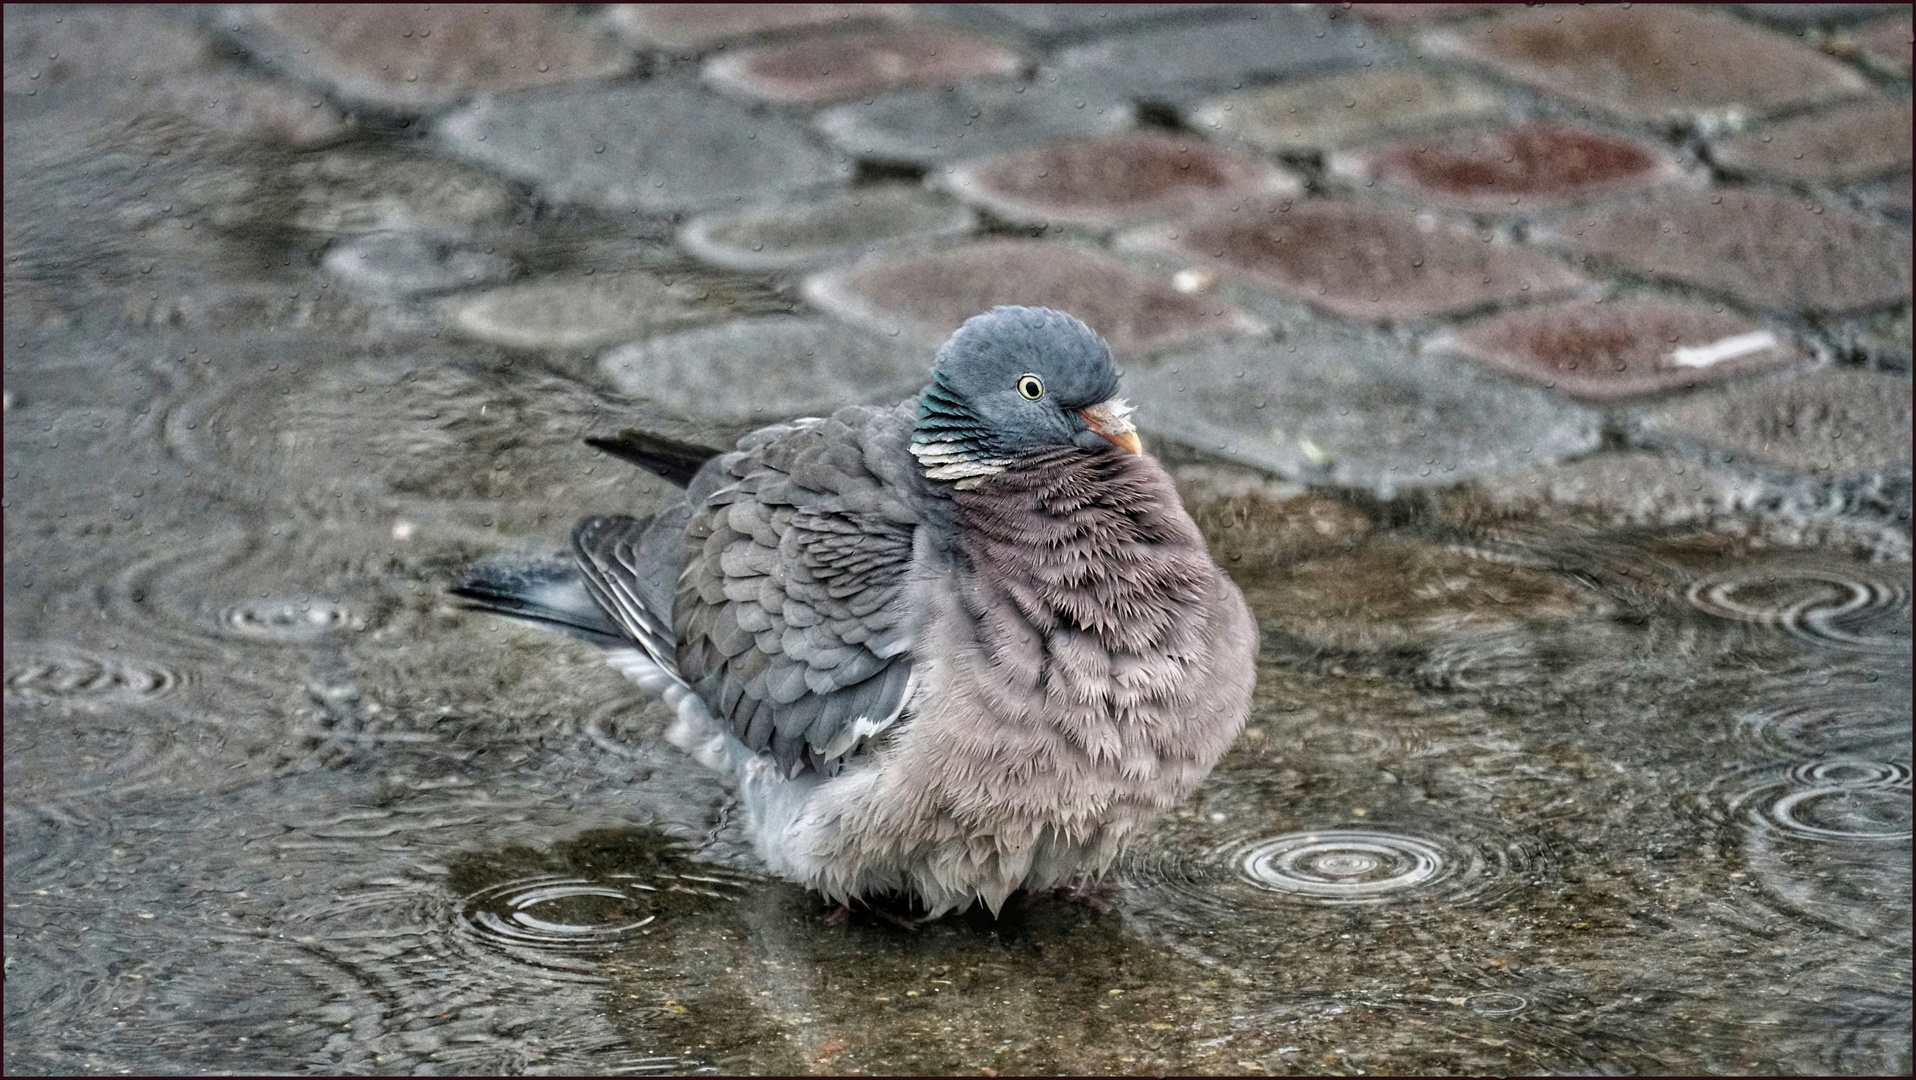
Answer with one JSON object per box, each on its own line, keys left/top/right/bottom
{"left": 4, "top": 4, "right": 1912, "bottom": 1074}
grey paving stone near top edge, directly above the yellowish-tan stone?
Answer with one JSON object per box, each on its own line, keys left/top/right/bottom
{"left": 1050, "top": 4, "right": 1391, "bottom": 101}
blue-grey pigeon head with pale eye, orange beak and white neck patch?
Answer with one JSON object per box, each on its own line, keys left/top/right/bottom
{"left": 912, "top": 306, "right": 1142, "bottom": 486}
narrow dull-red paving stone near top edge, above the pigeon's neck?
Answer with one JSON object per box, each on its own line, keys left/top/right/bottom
{"left": 705, "top": 27, "right": 1027, "bottom": 105}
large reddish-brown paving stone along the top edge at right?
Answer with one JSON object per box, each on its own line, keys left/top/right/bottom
{"left": 1426, "top": 4, "right": 1866, "bottom": 121}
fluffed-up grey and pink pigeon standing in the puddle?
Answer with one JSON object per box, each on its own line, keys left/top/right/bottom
{"left": 454, "top": 306, "right": 1257, "bottom": 915}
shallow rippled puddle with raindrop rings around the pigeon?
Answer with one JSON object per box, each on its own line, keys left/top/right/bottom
{"left": 4, "top": 4, "right": 1910, "bottom": 1074}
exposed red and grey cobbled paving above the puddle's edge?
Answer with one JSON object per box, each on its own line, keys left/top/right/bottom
{"left": 6, "top": 4, "right": 1910, "bottom": 519}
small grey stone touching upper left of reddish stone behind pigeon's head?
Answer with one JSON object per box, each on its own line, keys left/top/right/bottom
{"left": 678, "top": 184, "right": 977, "bottom": 270}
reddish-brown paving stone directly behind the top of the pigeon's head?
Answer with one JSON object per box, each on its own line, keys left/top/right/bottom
{"left": 805, "top": 239, "right": 1263, "bottom": 352}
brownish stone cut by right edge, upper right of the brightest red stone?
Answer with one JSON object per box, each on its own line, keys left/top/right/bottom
{"left": 1715, "top": 98, "right": 1912, "bottom": 184}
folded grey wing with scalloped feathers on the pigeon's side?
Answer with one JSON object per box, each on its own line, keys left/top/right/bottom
{"left": 673, "top": 406, "right": 927, "bottom": 776}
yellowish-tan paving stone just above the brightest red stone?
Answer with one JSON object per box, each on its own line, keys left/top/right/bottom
{"left": 1190, "top": 65, "right": 1508, "bottom": 153}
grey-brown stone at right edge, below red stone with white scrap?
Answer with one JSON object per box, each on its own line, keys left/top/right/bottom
{"left": 1642, "top": 368, "right": 1910, "bottom": 477}
